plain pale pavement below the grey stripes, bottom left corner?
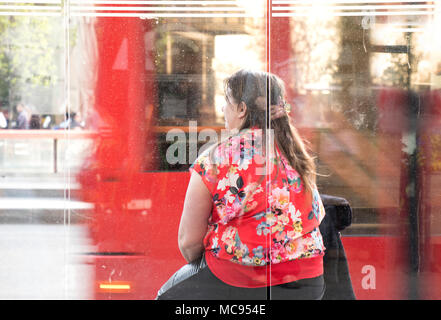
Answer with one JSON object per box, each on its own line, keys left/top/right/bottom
{"left": 0, "top": 224, "right": 94, "bottom": 300}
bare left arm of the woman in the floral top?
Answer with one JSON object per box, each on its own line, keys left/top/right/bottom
{"left": 178, "top": 171, "right": 212, "bottom": 262}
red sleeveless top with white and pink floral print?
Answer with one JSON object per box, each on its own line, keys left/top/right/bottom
{"left": 190, "top": 129, "right": 325, "bottom": 288}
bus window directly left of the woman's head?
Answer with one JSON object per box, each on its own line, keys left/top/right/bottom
{"left": 147, "top": 15, "right": 266, "bottom": 171}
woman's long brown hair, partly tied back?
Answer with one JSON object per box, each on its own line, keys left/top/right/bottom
{"left": 224, "top": 70, "right": 316, "bottom": 191}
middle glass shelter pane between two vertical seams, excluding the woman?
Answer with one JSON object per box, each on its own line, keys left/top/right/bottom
{"left": 73, "top": 1, "right": 267, "bottom": 299}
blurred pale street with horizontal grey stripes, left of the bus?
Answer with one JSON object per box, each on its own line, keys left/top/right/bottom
{"left": 0, "top": 175, "right": 94, "bottom": 300}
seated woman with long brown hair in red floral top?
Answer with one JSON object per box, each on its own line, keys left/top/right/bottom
{"left": 158, "top": 70, "right": 325, "bottom": 300}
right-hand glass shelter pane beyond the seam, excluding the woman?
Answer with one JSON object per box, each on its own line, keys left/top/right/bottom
{"left": 271, "top": 1, "right": 439, "bottom": 299}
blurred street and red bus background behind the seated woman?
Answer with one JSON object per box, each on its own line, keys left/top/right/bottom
{"left": 0, "top": 0, "right": 441, "bottom": 299}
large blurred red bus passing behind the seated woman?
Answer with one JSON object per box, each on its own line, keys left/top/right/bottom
{"left": 74, "top": 1, "right": 441, "bottom": 299}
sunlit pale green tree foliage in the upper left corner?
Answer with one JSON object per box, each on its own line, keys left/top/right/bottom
{"left": 0, "top": 16, "right": 63, "bottom": 107}
